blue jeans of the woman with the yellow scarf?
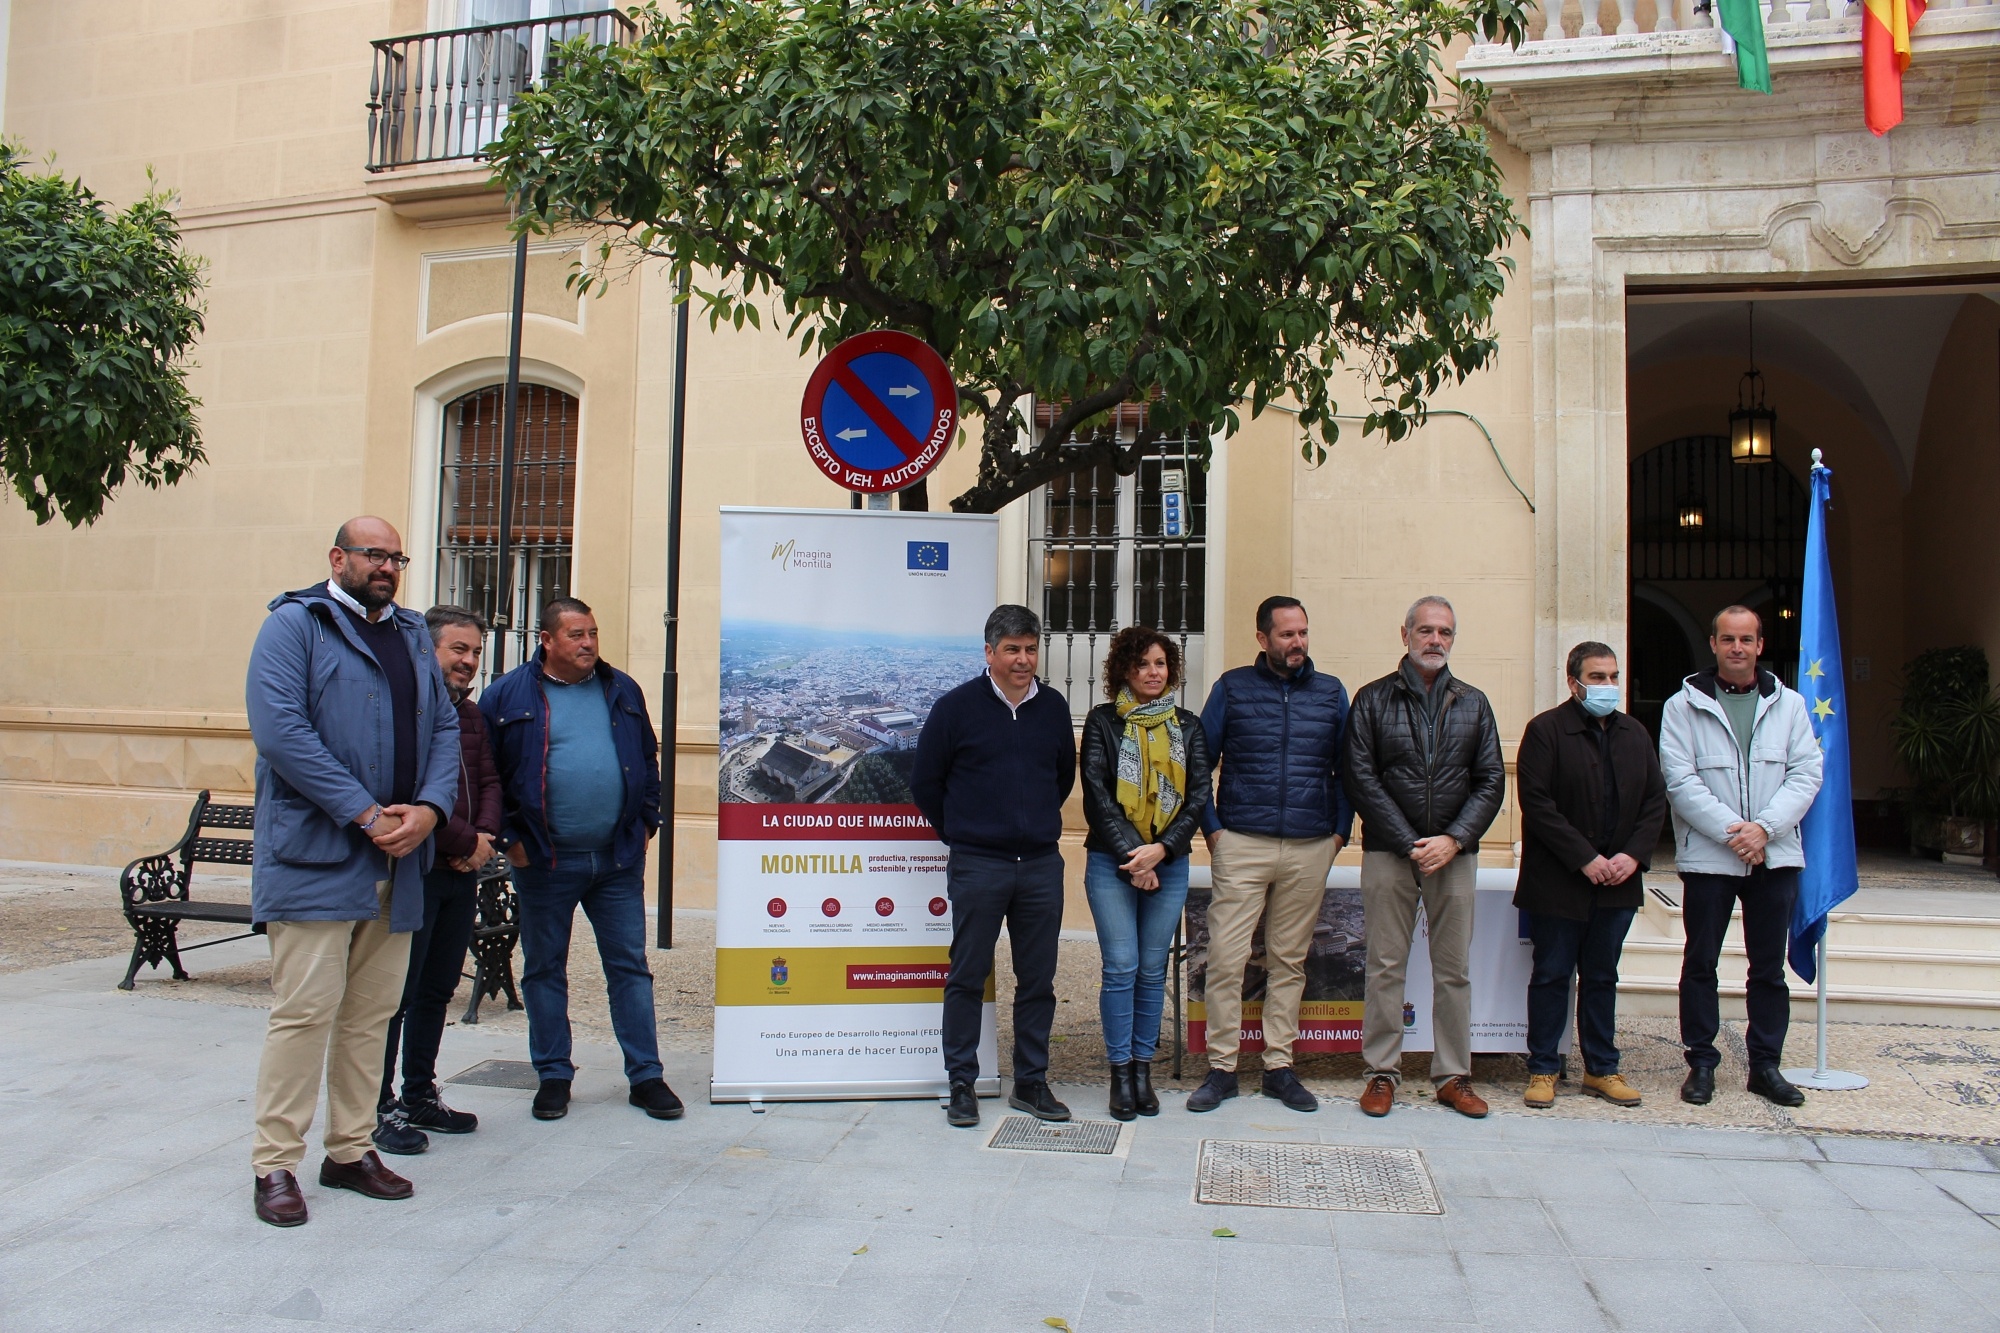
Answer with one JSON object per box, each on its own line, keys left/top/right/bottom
{"left": 1084, "top": 853, "right": 1188, "bottom": 1065}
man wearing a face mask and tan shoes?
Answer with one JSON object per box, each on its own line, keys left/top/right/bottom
{"left": 1514, "top": 642, "right": 1666, "bottom": 1111}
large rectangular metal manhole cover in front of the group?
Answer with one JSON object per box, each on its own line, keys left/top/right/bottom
{"left": 1194, "top": 1139, "right": 1444, "bottom": 1213}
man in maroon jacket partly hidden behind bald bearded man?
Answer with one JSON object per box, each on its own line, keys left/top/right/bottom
{"left": 374, "top": 606, "right": 500, "bottom": 1157}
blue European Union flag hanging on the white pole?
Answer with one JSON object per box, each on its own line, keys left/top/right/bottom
{"left": 1790, "top": 450, "right": 1860, "bottom": 981}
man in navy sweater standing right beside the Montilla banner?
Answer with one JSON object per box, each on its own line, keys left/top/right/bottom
{"left": 910, "top": 606, "right": 1076, "bottom": 1127}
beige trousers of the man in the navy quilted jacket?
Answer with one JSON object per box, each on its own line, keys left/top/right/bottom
{"left": 1202, "top": 829, "right": 1334, "bottom": 1073}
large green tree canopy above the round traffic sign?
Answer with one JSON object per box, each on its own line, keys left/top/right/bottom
{"left": 492, "top": 0, "right": 1524, "bottom": 512}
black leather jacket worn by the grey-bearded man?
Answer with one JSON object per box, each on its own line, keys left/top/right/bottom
{"left": 1340, "top": 667, "right": 1506, "bottom": 857}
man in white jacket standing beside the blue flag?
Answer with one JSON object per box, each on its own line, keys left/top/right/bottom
{"left": 1660, "top": 606, "right": 1820, "bottom": 1107}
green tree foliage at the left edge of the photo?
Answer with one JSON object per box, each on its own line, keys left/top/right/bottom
{"left": 0, "top": 142, "right": 204, "bottom": 526}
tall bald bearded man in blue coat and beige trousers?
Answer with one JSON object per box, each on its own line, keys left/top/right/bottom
{"left": 244, "top": 518, "right": 458, "bottom": 1227}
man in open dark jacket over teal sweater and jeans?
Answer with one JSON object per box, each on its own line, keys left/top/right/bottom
{"left": 480, "top": 596, "right": 682, "bottom": 1121}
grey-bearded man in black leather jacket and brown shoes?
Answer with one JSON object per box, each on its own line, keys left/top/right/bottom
{"left": 1344, "top": 596, "right": 1506, "bottom": 1119}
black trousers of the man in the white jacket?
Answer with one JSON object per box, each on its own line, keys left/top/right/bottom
{"left": 1680, "top": 865, "right": 1798, "bottom": 1069}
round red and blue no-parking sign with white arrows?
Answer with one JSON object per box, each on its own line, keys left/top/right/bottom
{"left": 798, "top": 330, "right": 958, "bottom": 492}
